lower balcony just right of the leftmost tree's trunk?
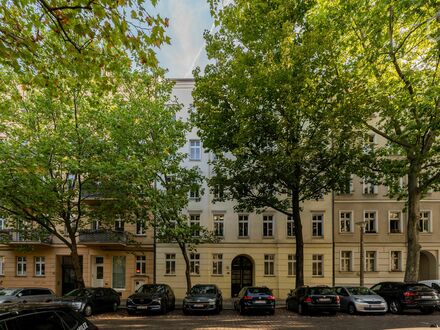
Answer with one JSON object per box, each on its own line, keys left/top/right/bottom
{"left": 79, "top": 229, "right": 129, "bottom": 246}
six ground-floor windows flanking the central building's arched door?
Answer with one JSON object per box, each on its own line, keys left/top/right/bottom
{"left": 165, "top": 253, "right": 324, "bottom": 276}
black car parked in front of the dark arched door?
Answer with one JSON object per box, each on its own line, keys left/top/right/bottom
{"left": 234, "top": 286, "right": 275, "bottom": 315}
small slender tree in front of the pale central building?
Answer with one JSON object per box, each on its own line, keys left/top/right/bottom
{"left": 153, "top": 166, "right": 219, "bottom": 292}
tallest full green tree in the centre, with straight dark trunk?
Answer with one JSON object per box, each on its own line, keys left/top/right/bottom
{"left": 192, "top": 0, "right": 350, "bottom": 287}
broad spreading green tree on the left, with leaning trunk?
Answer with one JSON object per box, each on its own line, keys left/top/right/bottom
{"left": 0, "top": 58, "right": 185, "bottom": 286}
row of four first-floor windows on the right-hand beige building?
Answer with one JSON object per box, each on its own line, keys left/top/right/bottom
{"left": 339, "top": 211, "right": 432, "bottom": 233}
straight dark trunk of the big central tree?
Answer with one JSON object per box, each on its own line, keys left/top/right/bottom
{"left": 292, "top": 190, "right": 304, "bottom": 288}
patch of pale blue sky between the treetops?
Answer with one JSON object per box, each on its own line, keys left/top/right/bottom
{"left": 153, "top": 0, "right": 213, "bottom": 78}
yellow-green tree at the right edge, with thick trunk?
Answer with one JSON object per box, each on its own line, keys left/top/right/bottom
{"left": 311, "top": 0, "right": 440, "bottom": 281}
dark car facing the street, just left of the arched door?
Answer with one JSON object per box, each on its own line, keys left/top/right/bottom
{"left": 182, "top": 284, "right": 223, "bottom": 314}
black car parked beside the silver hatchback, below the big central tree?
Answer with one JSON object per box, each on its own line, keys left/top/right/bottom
{"left": 286, "top": 286, "right": 340, "bottom": 315}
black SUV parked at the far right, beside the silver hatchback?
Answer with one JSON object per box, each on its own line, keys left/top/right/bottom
{"left": 371, "top": 282, "right": 440, "bottom": 314}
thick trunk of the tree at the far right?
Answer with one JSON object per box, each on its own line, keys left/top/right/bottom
{"left": 405, "top": 163, "right": 421, "bottom": 282}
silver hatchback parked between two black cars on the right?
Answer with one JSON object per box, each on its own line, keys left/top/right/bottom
{"left": 335, "top": 286, "right": 388, "bottom": 314}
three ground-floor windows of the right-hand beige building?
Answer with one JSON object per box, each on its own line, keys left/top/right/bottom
{"left": 339, "top": 251, "right": 402, "bottom": 272}
